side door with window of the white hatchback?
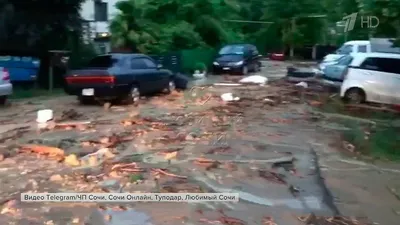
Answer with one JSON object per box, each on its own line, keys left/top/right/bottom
{"left": 358, "top": 57, "right": 393, "bottom": 104}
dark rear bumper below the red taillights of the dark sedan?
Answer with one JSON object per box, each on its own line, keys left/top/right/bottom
{"left": 65, "top": 85, "right": 129, "bottom": 98}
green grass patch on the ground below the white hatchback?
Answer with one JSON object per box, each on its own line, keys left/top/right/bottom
{"left": 321, "top": 96, "right": 400, "bottom": 160}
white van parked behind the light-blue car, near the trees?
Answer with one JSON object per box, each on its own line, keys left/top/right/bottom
{"left": 321, "top": 41, "right": 371, "bottom": 65}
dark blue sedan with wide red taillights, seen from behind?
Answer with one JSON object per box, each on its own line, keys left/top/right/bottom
{"left": 65, "top": 53, "right": 186, "bottom": 104}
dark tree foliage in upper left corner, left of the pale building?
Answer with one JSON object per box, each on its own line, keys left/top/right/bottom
{"left": 0, "top": 0, "right": 84, "bottom": 51}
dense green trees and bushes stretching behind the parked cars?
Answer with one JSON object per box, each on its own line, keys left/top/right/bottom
{"left": 111, "top": 0, "right": 400, "bottom": 54}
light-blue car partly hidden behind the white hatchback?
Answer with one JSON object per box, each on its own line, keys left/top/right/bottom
{"left": 320, "top": 54, "right": 353, "bottom": 88}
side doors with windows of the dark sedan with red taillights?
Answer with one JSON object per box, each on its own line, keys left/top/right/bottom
{"left": 131, "top": 57, "right": 159, "bottom": 93}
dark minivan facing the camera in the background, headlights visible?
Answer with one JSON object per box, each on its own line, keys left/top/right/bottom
{"left": 213, "top": 44, "right": 261, "bottom": 75}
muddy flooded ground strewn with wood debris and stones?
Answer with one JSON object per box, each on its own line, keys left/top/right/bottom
{"left": 0, "top": 60, "right": 400, "bottom": 225}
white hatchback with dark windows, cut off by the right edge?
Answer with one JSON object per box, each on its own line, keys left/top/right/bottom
{"left": 340, "top": 53, "right": 400, "bottom": 105}
